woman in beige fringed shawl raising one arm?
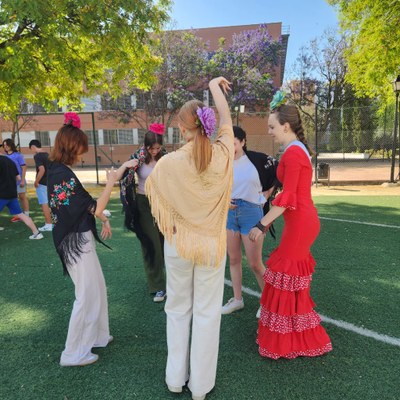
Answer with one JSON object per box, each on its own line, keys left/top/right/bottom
{"left": 146, "top": 77, "right": 234, "bottom": 400}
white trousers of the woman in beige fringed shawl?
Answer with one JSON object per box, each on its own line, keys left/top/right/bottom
{"left": 164, "top": 240, "right": 225, "bottom": 396}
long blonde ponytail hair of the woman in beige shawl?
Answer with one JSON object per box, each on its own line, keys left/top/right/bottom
{"left": 178, "top": 100, "right": 212, "bottom": 174}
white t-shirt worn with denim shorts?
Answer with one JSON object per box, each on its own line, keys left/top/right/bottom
{"left": 231, "top": 154, "right": 266, "bottom": 204}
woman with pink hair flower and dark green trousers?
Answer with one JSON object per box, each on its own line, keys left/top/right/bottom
{"left": 121, "top": 124, "right": 166, "bottom": 302}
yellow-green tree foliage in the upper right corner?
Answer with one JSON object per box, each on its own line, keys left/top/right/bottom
{"left": 328, "top": 0, "right": 400, "bottom": 104}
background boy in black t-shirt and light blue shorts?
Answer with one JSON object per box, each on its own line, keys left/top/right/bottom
{"left": 29, "top": 139, "right": 53, "bottom": 232}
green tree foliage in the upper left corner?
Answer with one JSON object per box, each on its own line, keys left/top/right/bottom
{"left": 0, "top": 0, "right": 170, "bottom": 119}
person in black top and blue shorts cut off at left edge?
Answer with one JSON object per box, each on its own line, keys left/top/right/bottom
{"left": 0, "top": 155, "right": 43, "bottom": 240}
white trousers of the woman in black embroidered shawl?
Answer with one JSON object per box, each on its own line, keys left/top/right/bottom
{"left": 61, "top": 231, "right": 110, "bottom": 364}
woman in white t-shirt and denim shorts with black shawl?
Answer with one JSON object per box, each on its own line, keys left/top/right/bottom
{"left": 222, "top": 126, "right": 277, "bottom": 317}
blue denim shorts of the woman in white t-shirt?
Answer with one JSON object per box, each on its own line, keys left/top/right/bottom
{"left": 226, "top": 199, "right": 264, "bottom": 235}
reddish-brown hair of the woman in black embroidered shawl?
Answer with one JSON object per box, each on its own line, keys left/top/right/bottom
{"left": 49, "top": 124, "right": 89, "bottom": 165}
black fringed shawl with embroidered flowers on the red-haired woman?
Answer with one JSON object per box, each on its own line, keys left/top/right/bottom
{"left": 47, "top": 162, "right": 108, "bottom": 274}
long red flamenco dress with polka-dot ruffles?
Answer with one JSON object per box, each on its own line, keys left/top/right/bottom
{"left": 257, "top": 142, "right": 332, "bottom": 360}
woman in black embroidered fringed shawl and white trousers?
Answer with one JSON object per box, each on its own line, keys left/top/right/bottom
{"left": 47, "top": 113, "right": 133, "bottom": 366}
